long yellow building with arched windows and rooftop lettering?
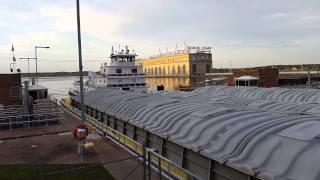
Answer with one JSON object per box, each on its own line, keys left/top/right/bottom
{"left": 137, "top": 47, "right": 212, "bottom": 77}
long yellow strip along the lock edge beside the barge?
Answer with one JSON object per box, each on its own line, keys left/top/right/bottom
{"left": 61, "top": 101, "right": 192, "bottom": 180}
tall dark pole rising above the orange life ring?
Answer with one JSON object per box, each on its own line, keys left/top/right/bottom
{"left": 76, "top": 0, "right": 85, "bottom": 122}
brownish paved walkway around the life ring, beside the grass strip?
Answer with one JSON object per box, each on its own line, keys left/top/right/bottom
{"left": 0, "top": 113, "right": 164, "bottom": 179}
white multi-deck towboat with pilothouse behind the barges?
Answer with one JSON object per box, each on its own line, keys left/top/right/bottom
{"left": 70, "top": 46, "right": 148, "bottom": 95}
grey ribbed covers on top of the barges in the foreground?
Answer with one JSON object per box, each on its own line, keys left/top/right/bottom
{"left": 74, "top": 86, "right": 320, "bottom": 180}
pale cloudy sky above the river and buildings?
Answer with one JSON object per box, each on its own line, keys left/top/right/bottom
{"left": 0, "top": 0, "right": 320, "bottom": 73}
